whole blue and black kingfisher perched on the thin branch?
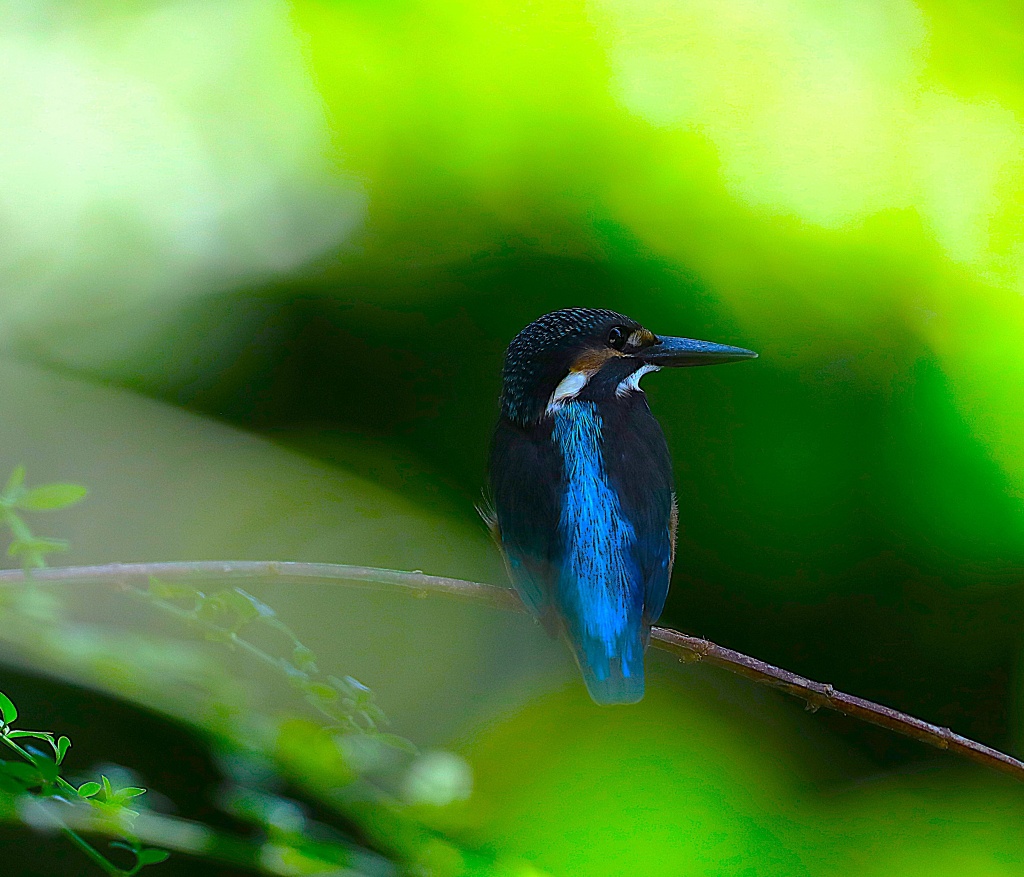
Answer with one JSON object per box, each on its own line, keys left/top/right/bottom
{"left": 487, "top": 307, "right": 757, "bottom": 704}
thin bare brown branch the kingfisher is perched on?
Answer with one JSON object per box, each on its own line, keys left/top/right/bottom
{"left": 0, "top": 560, "right": 1024, "bottom": 780}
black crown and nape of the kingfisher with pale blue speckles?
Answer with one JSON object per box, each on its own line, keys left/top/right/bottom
{"left": 502, "top": 307, "right": 640, "bottom": 424}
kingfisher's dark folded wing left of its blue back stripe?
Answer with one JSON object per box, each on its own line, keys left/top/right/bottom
{"left": 489, "top": 418, "right": 562, "bottom": 630}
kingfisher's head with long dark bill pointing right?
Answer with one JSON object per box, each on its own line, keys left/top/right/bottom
{"left": 502, "top": 307, "right": 757, "bottom": 425}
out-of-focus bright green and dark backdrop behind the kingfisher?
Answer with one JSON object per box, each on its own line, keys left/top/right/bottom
{"left": 0, "top": 0, "right": 1024, "bottom": 875}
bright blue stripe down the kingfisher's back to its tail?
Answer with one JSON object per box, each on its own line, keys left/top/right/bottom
{"left": 552, "top": 402, "right": 645, "bottom": 703}
